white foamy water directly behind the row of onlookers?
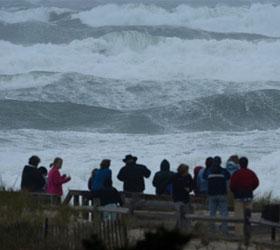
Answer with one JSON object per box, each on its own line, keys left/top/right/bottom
{"left": 0, "top": 130, "right": 280, "bottom": 196}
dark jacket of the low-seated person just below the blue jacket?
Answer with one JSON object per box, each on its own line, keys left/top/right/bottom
{"left": 97, "top": 187, "right": 123, "bottom": 206}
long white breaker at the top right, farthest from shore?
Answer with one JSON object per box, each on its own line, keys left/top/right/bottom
{"left": 72, "top": 4, "right": 280, "bottom": 36}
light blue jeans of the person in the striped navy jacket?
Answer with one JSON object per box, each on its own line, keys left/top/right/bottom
{"left": 208, "top": 195, "right": 228, "bottom": 233}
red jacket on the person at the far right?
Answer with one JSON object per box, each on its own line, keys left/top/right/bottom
{"left": 230, "top": 168, "right": 259, "bottom": 199}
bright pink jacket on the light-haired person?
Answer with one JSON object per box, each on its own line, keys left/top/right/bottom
{"left": 48, "top": 166, "right": 71, "bottom": 196}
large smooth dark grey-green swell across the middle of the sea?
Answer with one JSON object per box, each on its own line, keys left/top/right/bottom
{"left": 0, "top": 89, "right": 280, "bottom": 134}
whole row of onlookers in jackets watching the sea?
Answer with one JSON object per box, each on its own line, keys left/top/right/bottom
{"left": 21, "top": 155, "right": 259, "bottom": 233}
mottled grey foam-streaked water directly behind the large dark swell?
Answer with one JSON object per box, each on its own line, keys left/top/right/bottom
{"left": 0, "top": 72, "right": 280, "bottom": 111}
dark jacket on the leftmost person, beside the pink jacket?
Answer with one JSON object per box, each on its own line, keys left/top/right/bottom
{"left": 21, "top": 165, "right": 46, "bottom": 192}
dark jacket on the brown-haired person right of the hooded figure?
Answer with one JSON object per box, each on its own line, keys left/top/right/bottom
{"left": 172, "top": 173, "right": 193, "bottom": 203}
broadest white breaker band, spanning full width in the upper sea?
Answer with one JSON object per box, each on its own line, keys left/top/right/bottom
{"left": 0, "top": 32, "right": 280, "bottom": 81}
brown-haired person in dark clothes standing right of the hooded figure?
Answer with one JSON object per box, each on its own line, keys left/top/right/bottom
{"left": 172, "top": 164, "right": 193, "bottom": 229}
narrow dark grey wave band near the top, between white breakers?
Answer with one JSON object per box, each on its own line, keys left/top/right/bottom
{"left": 0, "top": 21, "right": 274, "bottom": 45}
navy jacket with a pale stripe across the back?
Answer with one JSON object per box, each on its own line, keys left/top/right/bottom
{"left": 203, "top": 166, "right": 230, "bottom": 196}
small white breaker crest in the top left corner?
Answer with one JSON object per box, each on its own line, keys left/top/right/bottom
{"left": 0, "top": 7, "right": 69, "bottom": 24}
